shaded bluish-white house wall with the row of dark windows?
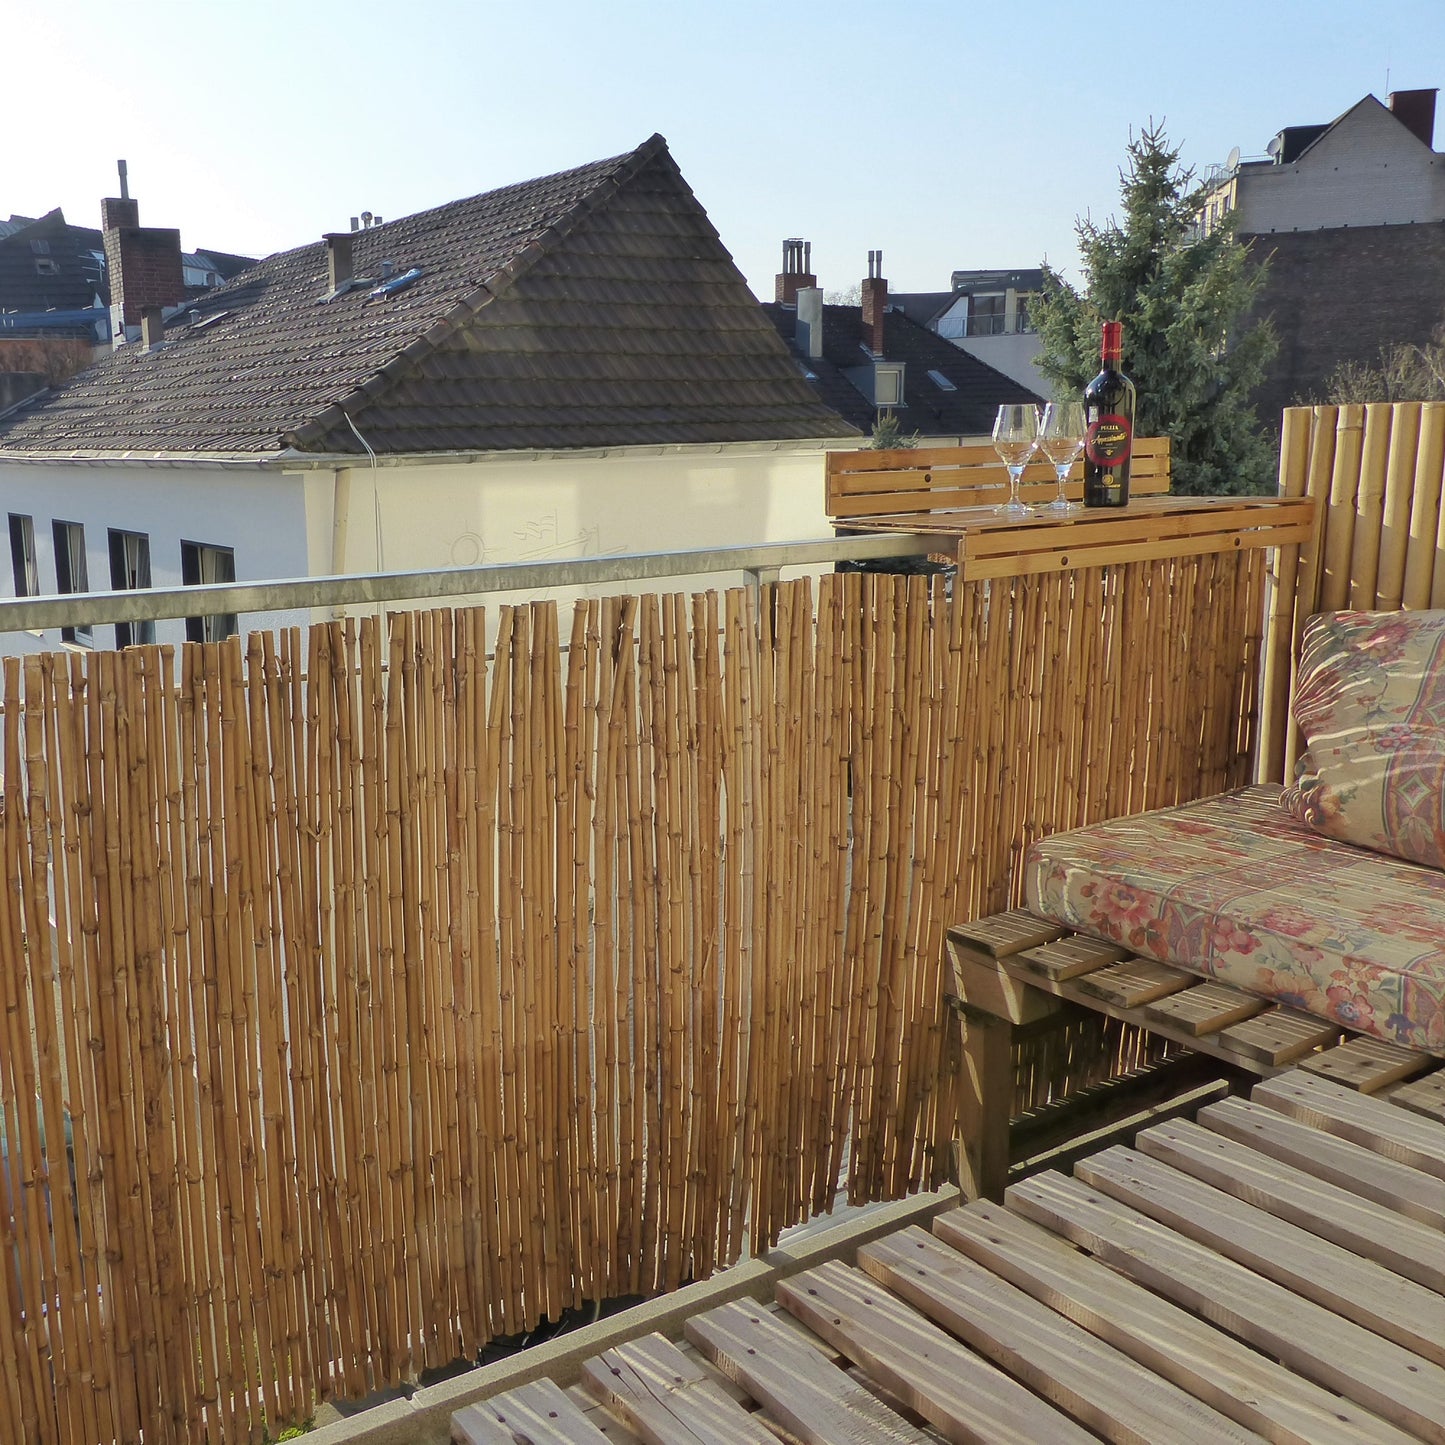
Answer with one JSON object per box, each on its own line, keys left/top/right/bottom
{"left": 0, "top": 461, "right": 315, "bottom": 655}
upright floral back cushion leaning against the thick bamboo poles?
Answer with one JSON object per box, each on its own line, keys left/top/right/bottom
{"left": 1285, "top": 611, "right": 1445, "bottom": 868}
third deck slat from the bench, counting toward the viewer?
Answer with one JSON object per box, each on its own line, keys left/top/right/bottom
{"left": 1137, "top": 1120, "right": 1445, "bottom": 1290}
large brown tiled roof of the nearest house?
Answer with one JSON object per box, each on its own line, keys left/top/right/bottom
{"left": 0, "top": 136, "right": 848, "bottom": 454}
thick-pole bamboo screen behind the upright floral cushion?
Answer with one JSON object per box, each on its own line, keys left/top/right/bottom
{"left": 1259, "top": 402, "right": 1445, "bottom": 782}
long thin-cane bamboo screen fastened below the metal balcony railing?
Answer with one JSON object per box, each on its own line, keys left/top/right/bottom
{"left": 0, "top": 551, "right": 1263, "bottom": 1442}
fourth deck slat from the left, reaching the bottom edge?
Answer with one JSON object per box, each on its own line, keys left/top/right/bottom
{"left": 777, "top": 1260, "right": 1092, "bottom": 1445}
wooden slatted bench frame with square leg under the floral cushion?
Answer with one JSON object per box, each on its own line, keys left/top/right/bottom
{"left": 948, "top": 909, "right": 1445, "bottom": 1199}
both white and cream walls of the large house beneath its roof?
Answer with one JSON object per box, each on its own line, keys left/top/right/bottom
{"left": 0, "top": 438, "right": 857, "bottom": 655}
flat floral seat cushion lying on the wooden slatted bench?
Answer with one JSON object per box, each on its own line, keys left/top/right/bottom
{"left": 1025, "top": 786, "right": 1445, "bottom": 1053}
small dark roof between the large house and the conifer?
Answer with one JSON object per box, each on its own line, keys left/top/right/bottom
{"left": 763, "top": 302, "right": 1043, "bottom": 436}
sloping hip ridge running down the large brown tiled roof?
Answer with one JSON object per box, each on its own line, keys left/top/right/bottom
{"left": 280, "top": 131, "right": 668, "bottom": 449}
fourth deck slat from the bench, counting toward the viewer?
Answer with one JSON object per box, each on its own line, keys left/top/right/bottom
{"left": 1074, "top": 1130, "right": 1445, "bottom": 1364}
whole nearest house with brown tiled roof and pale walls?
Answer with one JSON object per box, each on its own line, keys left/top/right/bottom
{"left": 0, "top": 136, "right": 860, "bottom": 652}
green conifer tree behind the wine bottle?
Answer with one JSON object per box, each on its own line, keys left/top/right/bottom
{"left": 1033, "top": 126, "right": 1279, "bottom": 496}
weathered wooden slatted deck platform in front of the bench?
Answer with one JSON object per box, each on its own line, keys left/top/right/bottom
{"left": 452, "top": 1068, "right": 1445, "bottom": 1445}
